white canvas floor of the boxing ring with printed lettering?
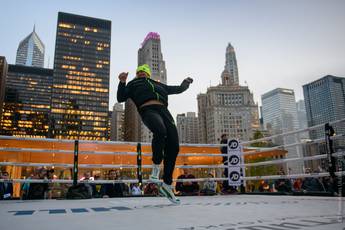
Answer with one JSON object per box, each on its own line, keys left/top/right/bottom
{"left": 0, "top": 195, "right": 345, "bottom": 230}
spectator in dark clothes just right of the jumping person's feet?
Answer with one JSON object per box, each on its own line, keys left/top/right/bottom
{"left": 176, "top": 164, "right": 199, "bottom": 196}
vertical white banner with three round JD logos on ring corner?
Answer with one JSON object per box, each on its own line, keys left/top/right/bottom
{"left": 227, "top": 139, "right": 243, "bottom": 186}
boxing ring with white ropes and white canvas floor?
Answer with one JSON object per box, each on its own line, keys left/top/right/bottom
{"left": 0, "top": 119, "right": 345, "bottom": 230}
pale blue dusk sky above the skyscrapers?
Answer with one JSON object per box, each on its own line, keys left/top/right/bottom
{"left": 0, "top": 1, "right": 345, "bottom": 117}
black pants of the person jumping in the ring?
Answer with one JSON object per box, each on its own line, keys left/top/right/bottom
{"left": 139, "top": 105, "right": 179, "bottom": 185}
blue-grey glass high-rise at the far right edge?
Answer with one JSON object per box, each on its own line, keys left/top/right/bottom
{"left": 303, "top": 75, "right": 345, "bottom": 139}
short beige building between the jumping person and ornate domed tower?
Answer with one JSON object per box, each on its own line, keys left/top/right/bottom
{"left": 176, "top": 112, "right": 199, "bottom": 143}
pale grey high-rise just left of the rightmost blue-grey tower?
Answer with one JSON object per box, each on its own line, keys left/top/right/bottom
{"left": 261, "top": 88, "right": 303, "bottom": 173}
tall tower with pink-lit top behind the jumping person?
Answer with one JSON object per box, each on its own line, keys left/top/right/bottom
{"left": 125, "top": 32, "right": 167, "bottom": 142}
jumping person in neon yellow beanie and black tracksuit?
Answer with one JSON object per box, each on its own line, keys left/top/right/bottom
{"left": 117, "top": 64, "right": 193, "bottom": 203}
